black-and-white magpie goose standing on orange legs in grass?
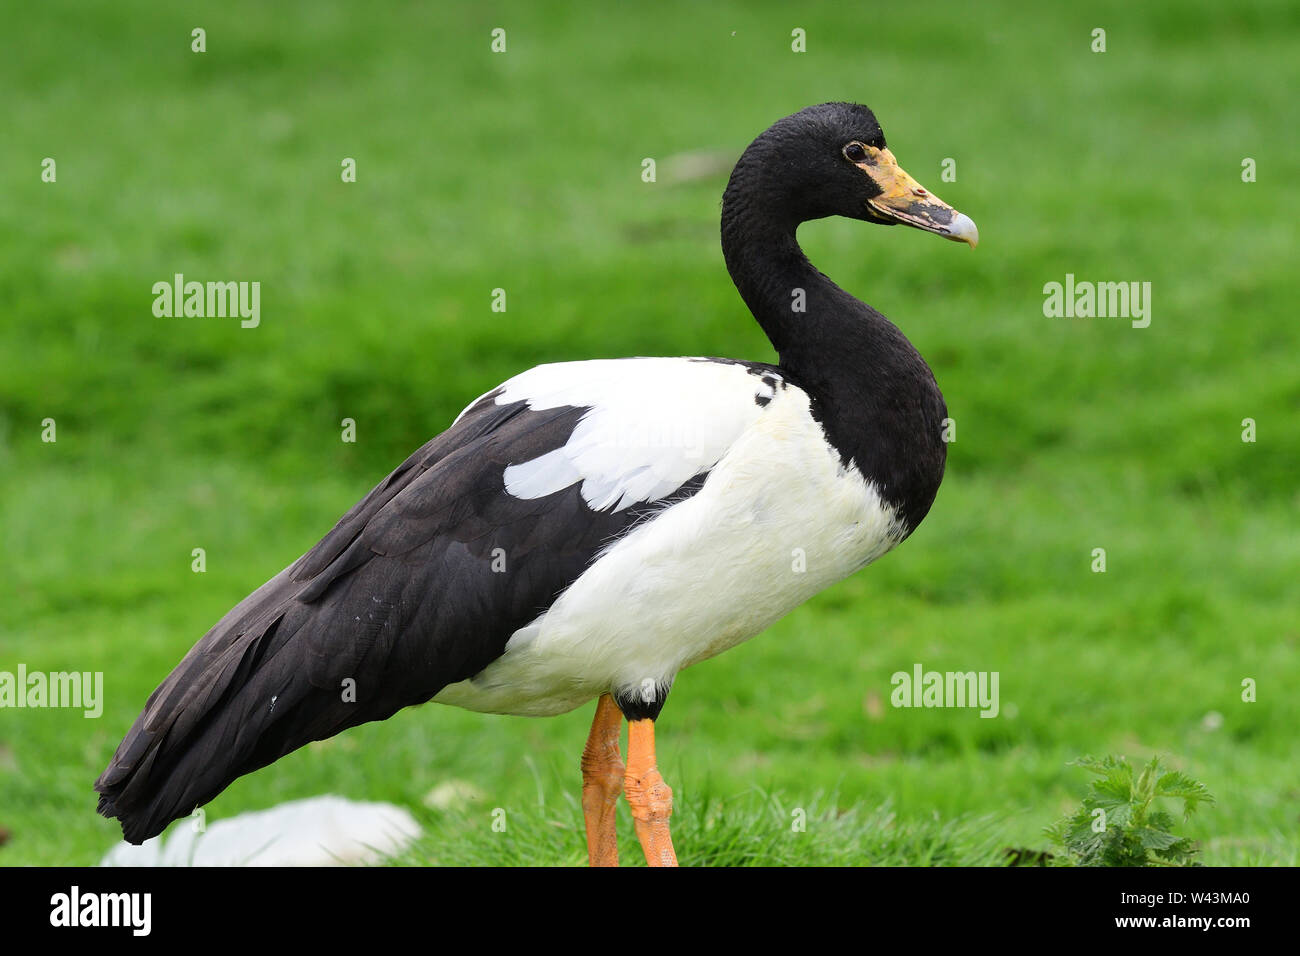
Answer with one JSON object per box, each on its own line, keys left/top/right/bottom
{"left": 95, "top": 103, "right": 978, "bottom": 865}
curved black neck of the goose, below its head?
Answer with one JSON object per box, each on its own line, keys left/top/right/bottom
{"left": 722, "top": 191, "right": 946, "bottom": 533}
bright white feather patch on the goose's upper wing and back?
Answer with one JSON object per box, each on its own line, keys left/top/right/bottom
{"left": 495, "top": 359, "right": 783, "bottom": 511}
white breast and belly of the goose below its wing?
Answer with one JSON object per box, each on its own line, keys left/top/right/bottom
{"left": 433, "top": 386, "right": 902, "bottom": 717}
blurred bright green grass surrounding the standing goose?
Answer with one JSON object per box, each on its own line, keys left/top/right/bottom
{"left": 0, "top": 0, "right": 1300, "bottom": 865}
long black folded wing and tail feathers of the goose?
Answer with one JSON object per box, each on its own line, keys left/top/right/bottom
{"left": 95, "top": 393, "right": 698, "bottom": 843}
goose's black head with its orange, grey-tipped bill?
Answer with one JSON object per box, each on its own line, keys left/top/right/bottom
{"left": 723, "top": 103, "right": 979, "bottom": 247}
